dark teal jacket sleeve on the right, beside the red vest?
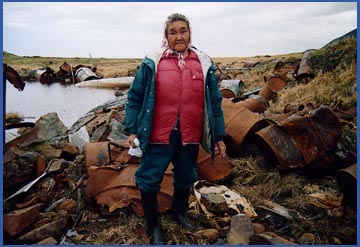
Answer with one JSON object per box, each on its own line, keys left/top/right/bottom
{"left": 208, "top": 63, "right": 225, "bottom": 142}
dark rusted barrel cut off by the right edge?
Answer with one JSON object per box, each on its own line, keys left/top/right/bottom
{"left": 336, "top": 163, "right": 357, "bottom": 210}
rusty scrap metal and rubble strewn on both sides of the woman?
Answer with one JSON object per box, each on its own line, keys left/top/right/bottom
{"left": 3, "top": 48, "right": 357, "bottom": 244}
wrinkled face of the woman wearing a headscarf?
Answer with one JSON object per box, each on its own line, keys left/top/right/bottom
{"left": 166, "top": 21, "right": 190, "bottom": 52}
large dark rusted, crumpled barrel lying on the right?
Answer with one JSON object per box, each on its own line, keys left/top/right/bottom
{"left": 256, "top": 106, "right": 341, "bottom": 169}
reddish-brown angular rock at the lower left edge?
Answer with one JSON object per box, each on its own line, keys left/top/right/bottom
{"left": 4, "top": 203, "right": 42, "bottom": 236}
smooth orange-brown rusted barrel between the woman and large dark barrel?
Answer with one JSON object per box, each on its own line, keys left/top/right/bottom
{"left": 222, "top": 100, "right": 270, "bottom": 156}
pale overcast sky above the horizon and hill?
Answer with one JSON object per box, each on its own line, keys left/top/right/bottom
{"left": 3, "top": 2, "right": 357, "bottom": 58}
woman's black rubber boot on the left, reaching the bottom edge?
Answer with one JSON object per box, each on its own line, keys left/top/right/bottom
{"left": 141, "top": 191, "right": 165, "bottom": 245}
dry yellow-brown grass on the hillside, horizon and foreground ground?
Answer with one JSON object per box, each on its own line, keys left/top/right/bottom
{"left": 3, "top": 38, "right": 357, "bottom": 245}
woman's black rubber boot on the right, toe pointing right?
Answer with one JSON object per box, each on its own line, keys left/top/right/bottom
{"left": 171, "top": 188, "right": 196, "bottom": 231}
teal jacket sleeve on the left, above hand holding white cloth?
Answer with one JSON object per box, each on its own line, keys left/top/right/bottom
{"left": 124, "top": 63, "right": 146, "bottom": 135}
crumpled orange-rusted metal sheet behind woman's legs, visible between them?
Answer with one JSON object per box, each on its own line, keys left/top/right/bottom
{"left": 86, "top": 164, "right": 173, "bottom": 216}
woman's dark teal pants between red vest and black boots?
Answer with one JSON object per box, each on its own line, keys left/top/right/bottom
{"left": 135, "top": 130, "right": 199, "bottom": 192}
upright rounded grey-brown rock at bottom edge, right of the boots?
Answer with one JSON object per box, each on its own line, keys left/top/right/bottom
{"left": 227, "top": 214, "right": 254, "bottom": 245}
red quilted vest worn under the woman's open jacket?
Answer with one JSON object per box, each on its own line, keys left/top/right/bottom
{"left": 150, "top": 51, "right": 204, "bottom": 144}
